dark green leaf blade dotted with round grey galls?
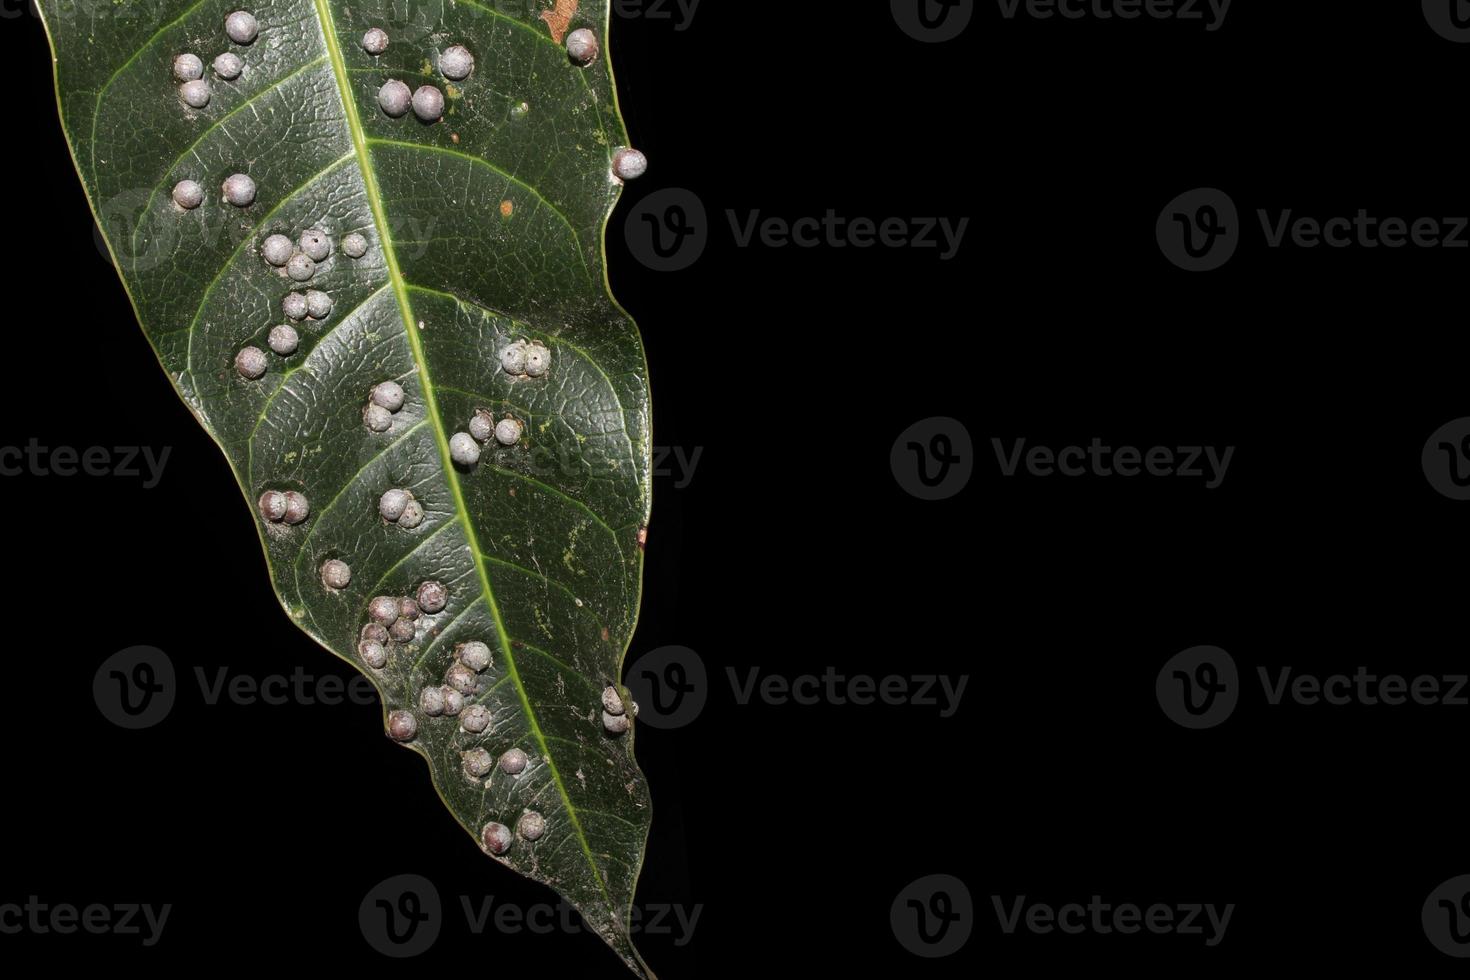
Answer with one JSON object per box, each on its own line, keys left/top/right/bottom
{"left": 40, "top": 0, "right": 651, "bottom": 976}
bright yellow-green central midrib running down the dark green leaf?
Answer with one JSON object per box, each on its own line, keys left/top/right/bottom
{"left": 313, "top": 0, "right": 616, "bottom": 911}
